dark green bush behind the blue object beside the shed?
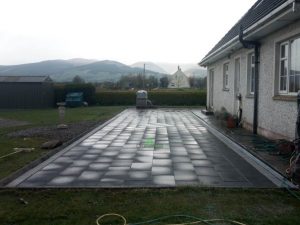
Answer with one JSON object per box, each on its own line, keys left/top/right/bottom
{"left": 54, "top": 84, "right": 96, "bottom": 105}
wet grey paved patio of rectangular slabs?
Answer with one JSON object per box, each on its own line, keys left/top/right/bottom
{"left": 8, "top": 109, "right": 275, "bottom": 187}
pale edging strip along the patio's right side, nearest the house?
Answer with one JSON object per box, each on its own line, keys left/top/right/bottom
{"left": 191, "top": 110, "right": 298, "bottom": 189}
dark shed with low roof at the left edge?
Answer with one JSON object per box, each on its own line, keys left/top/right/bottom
{"left": 0, "top": 76, "right": 54, "bottom": 109}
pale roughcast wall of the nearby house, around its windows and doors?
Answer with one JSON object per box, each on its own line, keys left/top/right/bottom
{"left": 208, "top": 18, "right": 300, "bottom": 140}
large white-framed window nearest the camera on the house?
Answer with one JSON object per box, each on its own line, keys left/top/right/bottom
{"left": 278, "top": 38, "right": 300, "bottom": 94}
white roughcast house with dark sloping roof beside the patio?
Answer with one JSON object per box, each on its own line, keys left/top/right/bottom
{"left": 199, "top": 0, "right": 300, "bottom": 140}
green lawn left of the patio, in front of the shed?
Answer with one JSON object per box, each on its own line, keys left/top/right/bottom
{"left": 0, "top": 106, "right": 125, "bottom": 180}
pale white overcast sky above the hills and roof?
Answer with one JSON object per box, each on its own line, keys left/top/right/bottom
{"left": 0, "top": 0, "right": 256, "bottom": 65}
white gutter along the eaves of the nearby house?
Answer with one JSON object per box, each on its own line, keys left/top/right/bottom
{"left": 199, "top": 0, "right": 299, "bottom": 66}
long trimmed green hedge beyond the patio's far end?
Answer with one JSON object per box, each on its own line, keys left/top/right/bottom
{"left": 96, "top": 91, "right": 206, "bottom": 106}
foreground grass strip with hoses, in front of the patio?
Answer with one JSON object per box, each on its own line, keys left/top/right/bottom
{"left": 0, "top": 188, "right": 300, "bottom": 225}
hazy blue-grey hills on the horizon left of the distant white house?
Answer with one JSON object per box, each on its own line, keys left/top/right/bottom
{"left": 0, "top": 58, "right": 163, "bottom": 82}
